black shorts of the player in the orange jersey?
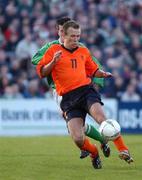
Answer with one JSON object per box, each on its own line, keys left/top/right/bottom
{"left": 60, "top": 85, "right": 103, "bottom": 122}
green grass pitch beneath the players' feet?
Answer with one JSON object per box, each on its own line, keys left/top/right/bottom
{"left": 0, "top": 135, "right": 142, "bottom": 180}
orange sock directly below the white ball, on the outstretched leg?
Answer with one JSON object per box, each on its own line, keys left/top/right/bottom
{"left": 113, "top": 135, "right": 128, "bottom": 151}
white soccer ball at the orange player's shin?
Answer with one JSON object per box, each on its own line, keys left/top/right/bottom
{"left": 99, "top": 119, "right": 121, "bottom": 141}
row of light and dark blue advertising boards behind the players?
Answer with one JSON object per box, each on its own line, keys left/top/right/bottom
{"left": 0, "top": 99, "right": 142, "bottom": 136}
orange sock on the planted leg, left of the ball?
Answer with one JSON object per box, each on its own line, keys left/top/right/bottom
{"left": 81, "top": 138, "right": 98, "bottom": 156}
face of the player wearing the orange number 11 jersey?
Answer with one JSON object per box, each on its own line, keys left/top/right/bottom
{"left": 63, "top": 27, "right": 81, "bottom": 49}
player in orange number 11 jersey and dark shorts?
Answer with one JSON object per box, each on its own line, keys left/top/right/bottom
{"left": 36, "top": 21, "right": 133, "bottom": 169}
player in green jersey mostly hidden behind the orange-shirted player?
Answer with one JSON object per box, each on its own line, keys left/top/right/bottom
{"left": 32, "top": 17, "right": 110, "bottom": 159}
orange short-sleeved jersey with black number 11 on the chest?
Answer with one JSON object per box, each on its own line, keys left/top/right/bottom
{"left": 37, "top": 44, "right": 98, "bottom": 96}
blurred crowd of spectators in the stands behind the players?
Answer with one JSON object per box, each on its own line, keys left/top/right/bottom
{"left": 0, "top": 0, "right": 142, "bottom": 101}
